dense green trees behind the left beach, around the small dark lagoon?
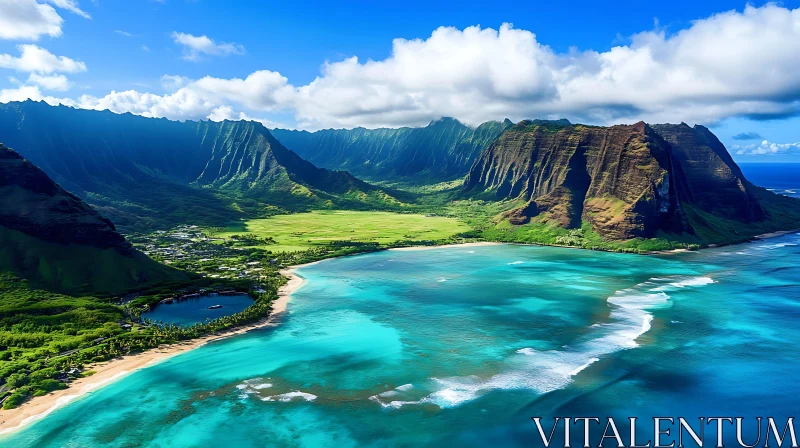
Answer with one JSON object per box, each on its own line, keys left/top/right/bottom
{"left": 0, "top": 274, "right": 282, "bottom": 409}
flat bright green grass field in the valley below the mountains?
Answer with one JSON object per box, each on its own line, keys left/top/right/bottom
{"left": 214, "top": 211, "right": 470, "bottom": 252}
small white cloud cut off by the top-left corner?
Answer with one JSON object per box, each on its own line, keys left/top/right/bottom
{"left": 0, "top": 0, "right": 64, "bottom": 40}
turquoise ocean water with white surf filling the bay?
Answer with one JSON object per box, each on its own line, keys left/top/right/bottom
{"left": 0, "top": 235, "right": 800, "bottom": 448}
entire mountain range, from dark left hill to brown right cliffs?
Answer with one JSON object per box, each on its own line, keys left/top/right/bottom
{"left": 0, "top": 101, "right": 800, "bottom": 293}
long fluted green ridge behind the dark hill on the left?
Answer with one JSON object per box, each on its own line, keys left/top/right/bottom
{"left": 0, "top": 101, "right": 398, "bottom": 228}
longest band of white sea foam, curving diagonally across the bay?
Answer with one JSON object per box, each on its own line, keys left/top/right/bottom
{"left": 384, "top": 276, "right": 714, "bottom": 408}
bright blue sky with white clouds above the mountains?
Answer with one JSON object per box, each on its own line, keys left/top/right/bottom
{"left": 0, "top": 0, "right": 800, "bottom": 162}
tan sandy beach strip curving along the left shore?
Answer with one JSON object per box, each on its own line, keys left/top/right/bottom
{"left": 0, "top": 263, "right": 312, "bottom": 434}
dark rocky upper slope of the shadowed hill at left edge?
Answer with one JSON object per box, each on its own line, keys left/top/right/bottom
{"left": 0, "top": 144, "right": 132, "bottom": 255}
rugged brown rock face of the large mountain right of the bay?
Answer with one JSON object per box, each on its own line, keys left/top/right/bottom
{"left": 464, "top": 121, "right": 765, "bottom": 240}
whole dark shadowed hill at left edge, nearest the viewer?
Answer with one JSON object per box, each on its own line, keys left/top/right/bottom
{"left": 0, "top": 144, "right": 188, "bottom": 294}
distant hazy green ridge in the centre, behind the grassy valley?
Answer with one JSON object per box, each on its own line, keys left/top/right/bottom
{"left": 272, "top": 118, "right": 512, "bottom": 183}
